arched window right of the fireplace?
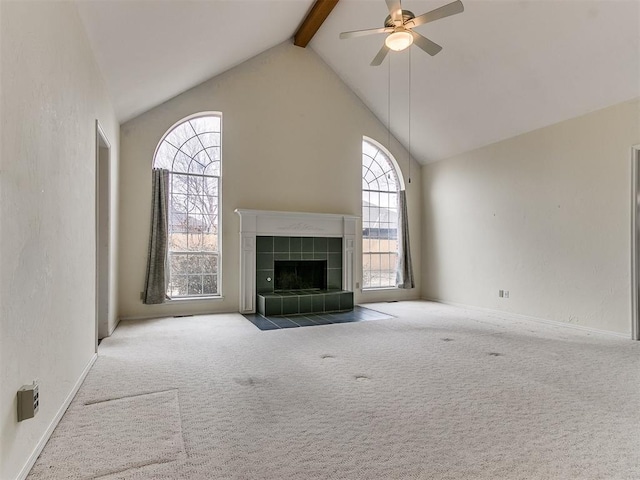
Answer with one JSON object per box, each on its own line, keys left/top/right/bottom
{"left": 362, "top": 137, "right": 403, "bottom": 289}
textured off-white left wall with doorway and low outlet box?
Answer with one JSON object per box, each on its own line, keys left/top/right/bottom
{"left": 0, "top": 1, "right": 119, "bottom": 479}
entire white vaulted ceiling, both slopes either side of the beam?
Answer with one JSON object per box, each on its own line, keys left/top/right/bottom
{"left": 78, "top": 0, "right": 640, "bottom": 163}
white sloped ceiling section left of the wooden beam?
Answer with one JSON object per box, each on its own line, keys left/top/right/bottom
{"left": 76, "top": 0, "right": 313, "bottom": 122}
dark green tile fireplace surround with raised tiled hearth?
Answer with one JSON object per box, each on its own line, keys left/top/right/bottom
{"left": 256, "top": 236, "right": 353, "bottom": 315}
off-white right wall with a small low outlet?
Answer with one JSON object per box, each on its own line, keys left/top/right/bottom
{"left": 423, "top": 99, "right": 640, "bottom": 335}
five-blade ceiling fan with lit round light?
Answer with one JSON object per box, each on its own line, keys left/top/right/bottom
{"left": 340, "top": 0, "right": 464, "bottom": 67}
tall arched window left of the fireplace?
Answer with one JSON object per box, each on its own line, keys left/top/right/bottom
{"left": 153, "top": 113, "right": 222, "bottom": 298}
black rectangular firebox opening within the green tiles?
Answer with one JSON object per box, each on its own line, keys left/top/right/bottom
{"left": 274, "top": 260, "right": 327, "bottom": 291}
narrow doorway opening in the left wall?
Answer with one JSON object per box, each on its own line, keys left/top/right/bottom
{"left": 96, "top": 120, "right": 111, "bottom": 352}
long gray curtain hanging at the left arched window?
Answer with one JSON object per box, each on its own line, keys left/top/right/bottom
{"left": 143, "top": 168, "right": 169, "bottom": 305}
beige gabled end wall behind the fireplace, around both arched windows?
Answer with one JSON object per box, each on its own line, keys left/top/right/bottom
{"left": 119, "top": 42, "right": 421, "bottom": 318}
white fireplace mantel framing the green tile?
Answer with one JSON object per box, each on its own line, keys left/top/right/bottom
{"left": 236, "top": 209, "right": 358, "bottom": 313}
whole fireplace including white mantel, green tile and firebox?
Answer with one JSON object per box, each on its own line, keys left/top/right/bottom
{"left": 236, "top": 209, "right": 358, "bottom": 314}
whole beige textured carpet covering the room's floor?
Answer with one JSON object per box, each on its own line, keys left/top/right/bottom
{"left": 29, "top": 302, "right": 640, "bottom": 480}
